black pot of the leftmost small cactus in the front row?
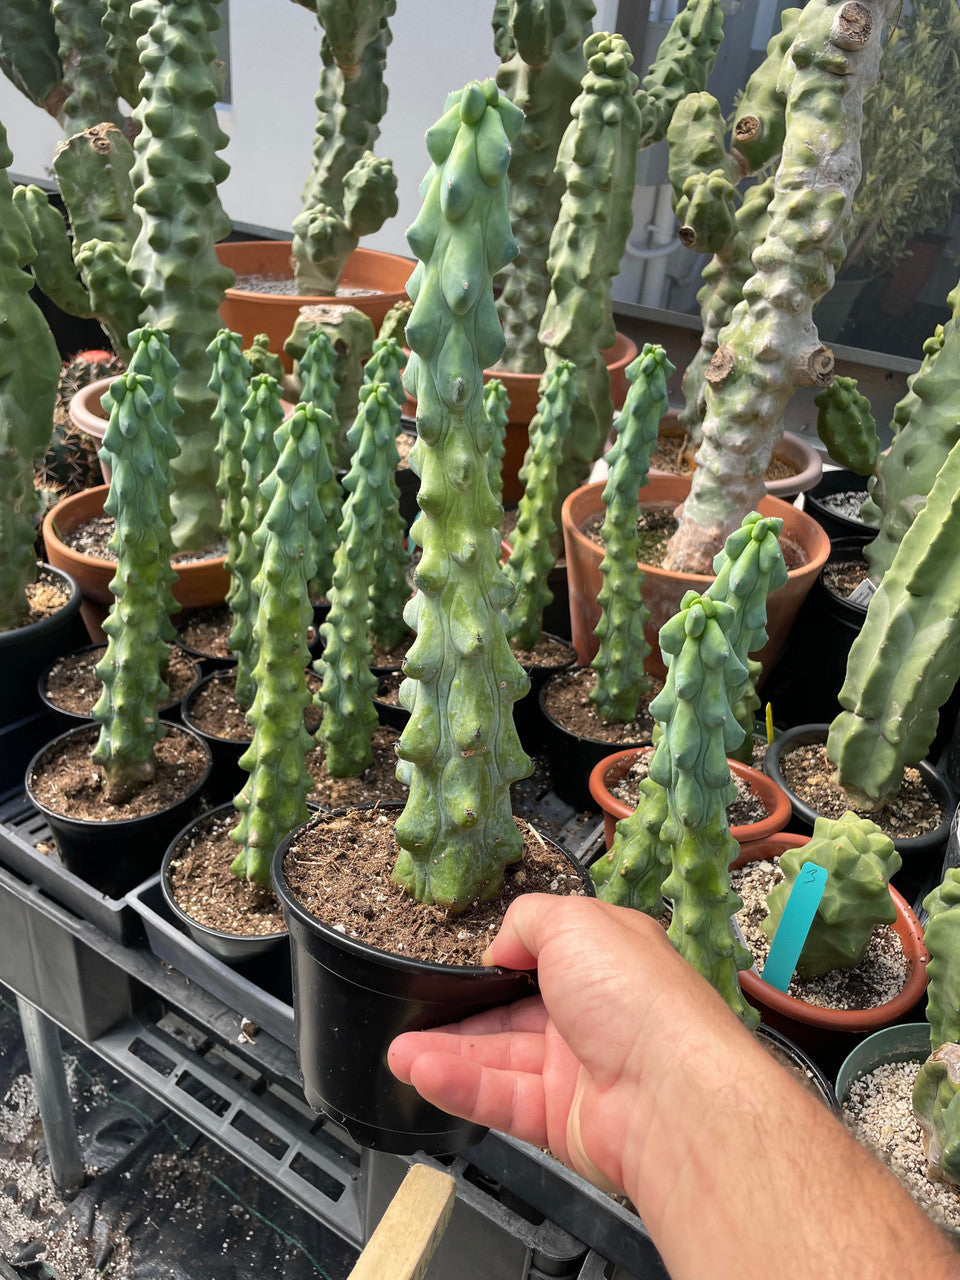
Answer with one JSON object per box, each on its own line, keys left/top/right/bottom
{"left": 26, "top": 724, "right": 211, "bottom": 899}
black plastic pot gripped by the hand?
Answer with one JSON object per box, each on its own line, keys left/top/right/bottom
{"left": 271, "top": 805, "right": 591, "bottom": 1155}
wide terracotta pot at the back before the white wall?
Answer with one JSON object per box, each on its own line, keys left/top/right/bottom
{"left": 216, "top": 241, "right": 416, "bottom": 372}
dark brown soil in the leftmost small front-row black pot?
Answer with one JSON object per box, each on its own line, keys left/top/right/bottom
{"left": 31, "top": 724, "right": 207, "bottom": 822}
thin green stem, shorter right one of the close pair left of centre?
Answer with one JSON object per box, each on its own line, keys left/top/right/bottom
{"left": 227, "top": 374, "right": 283, "bottom": 708}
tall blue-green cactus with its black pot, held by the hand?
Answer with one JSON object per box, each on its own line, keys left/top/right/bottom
{"left": 273, "top": 81, "right": 593, "bottom": 1151}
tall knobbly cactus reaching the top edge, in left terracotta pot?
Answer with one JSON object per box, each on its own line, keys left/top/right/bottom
{"left": 129, "top": 0, "right": 233, "bottom": 549}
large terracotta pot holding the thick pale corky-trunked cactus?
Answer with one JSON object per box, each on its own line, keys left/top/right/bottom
{"left": 561, "top": 475, "right": 829, "bottom": 680}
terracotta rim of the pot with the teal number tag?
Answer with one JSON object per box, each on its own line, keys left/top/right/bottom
{"left": 733, "top": 832, "right": 929, "bottom": 1033}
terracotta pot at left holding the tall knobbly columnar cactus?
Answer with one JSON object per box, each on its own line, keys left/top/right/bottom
{"left": 44, "top": 484, "right": 230, "bottom": 643}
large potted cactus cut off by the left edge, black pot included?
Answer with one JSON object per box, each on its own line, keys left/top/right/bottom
{"left": 0, "top": 125, "right": 81, "bottom": 728}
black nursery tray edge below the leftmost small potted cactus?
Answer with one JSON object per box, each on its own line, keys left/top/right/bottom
{"left": 0, "top": 792, "right": 143, "bottom": 946}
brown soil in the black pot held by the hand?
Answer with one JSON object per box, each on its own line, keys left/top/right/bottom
{"left": 283, "top": 810, "right": 584, "bottom": 965}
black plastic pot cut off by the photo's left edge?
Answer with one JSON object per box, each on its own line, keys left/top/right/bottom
{"left": 0, "top": 564, "right": 87, "bottom": 728}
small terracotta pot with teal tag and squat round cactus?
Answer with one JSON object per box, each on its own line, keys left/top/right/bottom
{"left": 732, "top": 832, "right": 929, "bottom": 1065}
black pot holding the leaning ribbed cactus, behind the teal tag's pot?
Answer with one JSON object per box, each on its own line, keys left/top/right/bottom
{"left": 763, "top": 724, "right": 956, "bottom": 910}
